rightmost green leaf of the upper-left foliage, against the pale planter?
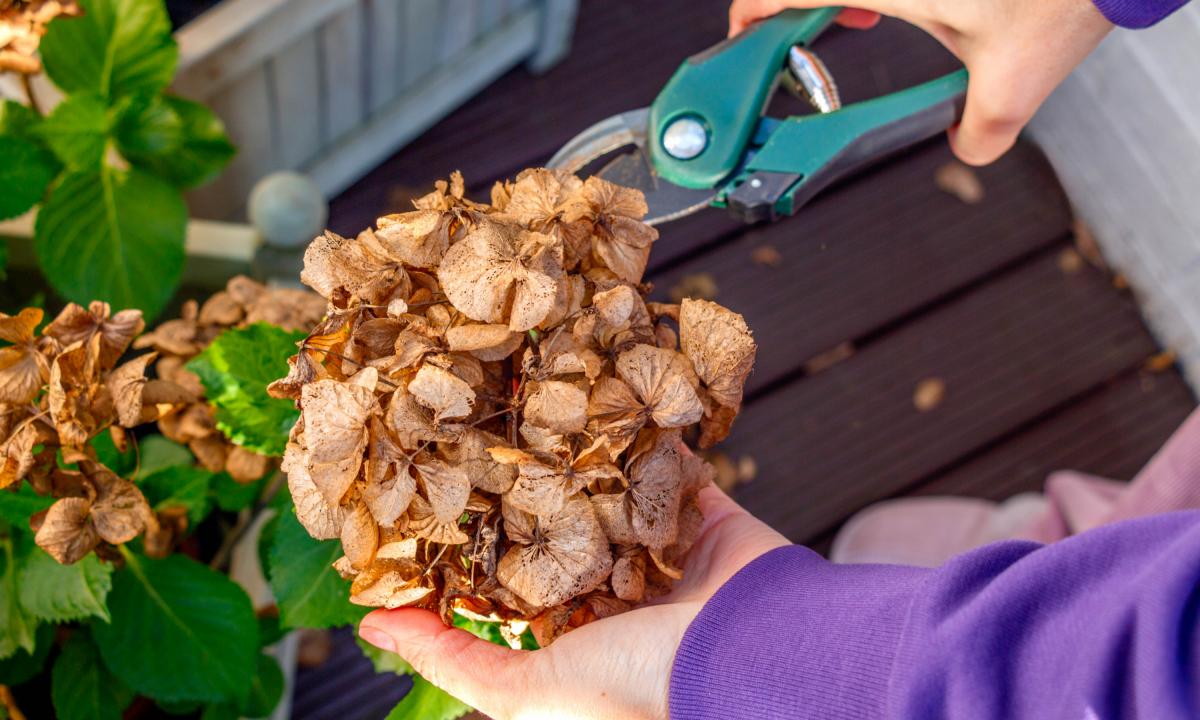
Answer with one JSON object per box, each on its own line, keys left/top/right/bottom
{"left": 121, "top": 95, "right": 238, "bottom": 187}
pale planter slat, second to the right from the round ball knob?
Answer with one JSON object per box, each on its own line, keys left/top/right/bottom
{"left": 313, "top": 2, "right": 368, "bottom": 142}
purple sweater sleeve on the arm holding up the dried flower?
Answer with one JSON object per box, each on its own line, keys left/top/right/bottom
{"left": 670, "top": 511, "right": 1200, "bottom": 720}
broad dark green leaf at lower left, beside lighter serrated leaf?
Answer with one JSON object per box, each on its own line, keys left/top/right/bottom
{"left": 95, "top": 551, "right": 258, "bottom": 702}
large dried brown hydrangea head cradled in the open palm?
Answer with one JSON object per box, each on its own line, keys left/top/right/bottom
{"left": 270, "top": 169, "right": 755, "bottom": 643}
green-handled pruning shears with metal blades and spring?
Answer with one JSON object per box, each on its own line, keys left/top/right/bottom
{"left": 548, "top": 7, "right": 967, "bottom": 224}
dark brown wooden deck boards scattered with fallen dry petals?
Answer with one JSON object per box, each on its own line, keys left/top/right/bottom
{"left": 294, "top": 0, "right": 1195, "bottom": 720}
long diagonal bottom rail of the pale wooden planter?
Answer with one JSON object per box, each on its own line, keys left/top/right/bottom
{"left": 305, "top": 10, "right": 540, "bottom": 197}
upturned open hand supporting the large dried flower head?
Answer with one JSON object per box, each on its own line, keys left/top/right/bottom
{"left": 359, "top": 486, "right": 790, "bottom": 720}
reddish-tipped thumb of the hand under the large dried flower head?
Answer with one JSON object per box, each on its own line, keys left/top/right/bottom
{"left": 359, "top": 607, "right": 528, "bottom": 715}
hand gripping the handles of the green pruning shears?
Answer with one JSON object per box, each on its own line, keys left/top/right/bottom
{"left": 730, "top": 0, "right": 1112, "bottom": 164}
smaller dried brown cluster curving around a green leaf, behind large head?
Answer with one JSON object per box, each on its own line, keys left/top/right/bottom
{"left": 133, "top": 276, "right": 325, "bottom": 482}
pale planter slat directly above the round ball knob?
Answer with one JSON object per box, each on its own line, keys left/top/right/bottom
{"left": 268, "top": 32, "right": 323, "bottom": 169}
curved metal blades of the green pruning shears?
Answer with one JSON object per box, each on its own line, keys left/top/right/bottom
{"left": 547, "top": 108, "right": 716, "bottom": 226}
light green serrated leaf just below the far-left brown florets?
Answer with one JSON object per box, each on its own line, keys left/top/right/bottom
{"left": 17, "top": 547, "right": 113, "bottom": 623}
